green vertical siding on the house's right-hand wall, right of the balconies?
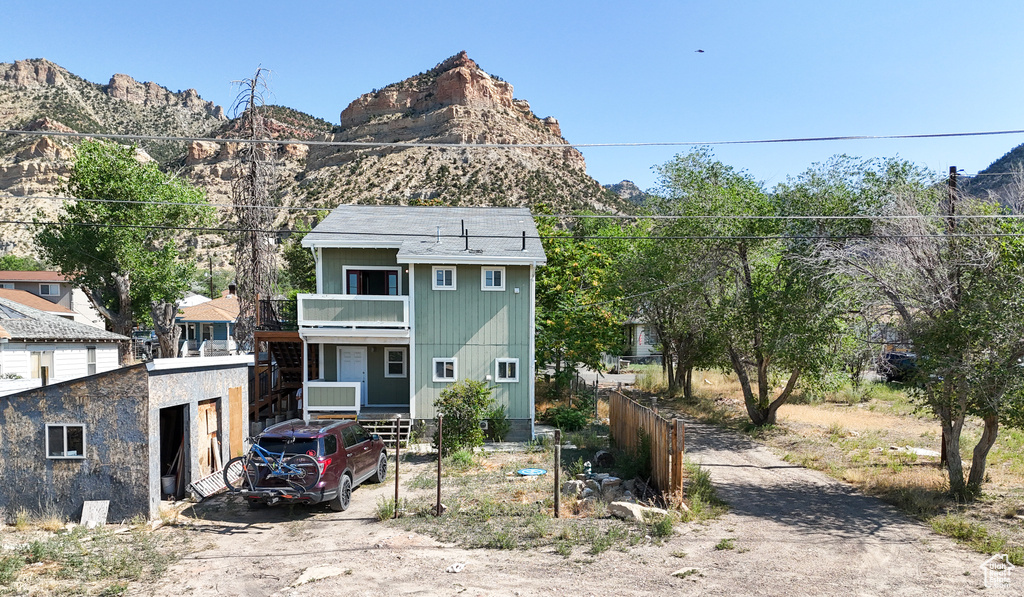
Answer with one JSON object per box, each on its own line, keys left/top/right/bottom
{"left": 413, "top": 265, "right": 534, "bottom": 419}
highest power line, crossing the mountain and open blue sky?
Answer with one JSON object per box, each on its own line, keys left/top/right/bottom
{"left": 6, "top": 129, "right": 1024, "bottom": 150}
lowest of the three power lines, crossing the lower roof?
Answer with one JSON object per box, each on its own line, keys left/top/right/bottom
{"left": 8, "top": 220, "right": 1024, "bottom": 241}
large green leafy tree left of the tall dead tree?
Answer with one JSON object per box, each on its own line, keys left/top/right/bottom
{"left": 36, "top": 141, "right": 213, "bottom": 356}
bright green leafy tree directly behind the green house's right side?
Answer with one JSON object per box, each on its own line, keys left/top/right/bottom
{"left": 537, "top": 212, "right": 624, "bottom": 387}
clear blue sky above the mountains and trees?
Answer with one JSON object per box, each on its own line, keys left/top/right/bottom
{"left": 0, "top": 0, "right": 1024, "bottom": 188}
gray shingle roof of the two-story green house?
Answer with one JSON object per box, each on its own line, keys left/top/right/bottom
{"left": 302, "top": 205, "right": 546, "bottom": 264}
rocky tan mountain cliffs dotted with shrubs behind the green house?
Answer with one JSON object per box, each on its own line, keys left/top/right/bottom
{"left": 0, "top": 52, "right": 630, "bottom": 262}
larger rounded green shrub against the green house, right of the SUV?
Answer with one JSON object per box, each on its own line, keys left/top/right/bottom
{"left": 434, "top": 379, "right": 494, "bottom": 456}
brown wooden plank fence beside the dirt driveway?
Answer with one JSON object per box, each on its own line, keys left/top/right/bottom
{"left": 608, "top": 390, "right": 685, "bottom": 499}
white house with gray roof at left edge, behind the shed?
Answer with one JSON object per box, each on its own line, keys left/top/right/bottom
{"left": 0, "top": 297, "right": 128, "bottom": 394}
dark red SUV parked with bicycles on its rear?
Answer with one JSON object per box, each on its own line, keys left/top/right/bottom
{"left": 237, "top": 419, "right": 387, "bottom": 512}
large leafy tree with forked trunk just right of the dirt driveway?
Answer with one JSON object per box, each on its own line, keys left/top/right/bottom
{"left": 654, "top": 148, "right": 838, "bottom": 426}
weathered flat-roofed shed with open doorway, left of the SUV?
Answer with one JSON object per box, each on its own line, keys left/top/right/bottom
{"left": 0, "top": 356, "right": 252, "bottom": 521}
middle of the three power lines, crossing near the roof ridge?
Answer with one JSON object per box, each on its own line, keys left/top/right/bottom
{"left": 0, "top": 195, "right": 1024, "bottom": 222}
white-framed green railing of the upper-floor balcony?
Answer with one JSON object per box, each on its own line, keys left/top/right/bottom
{"left": 298, "top": 294, "right": 409, "bottom": 329}
